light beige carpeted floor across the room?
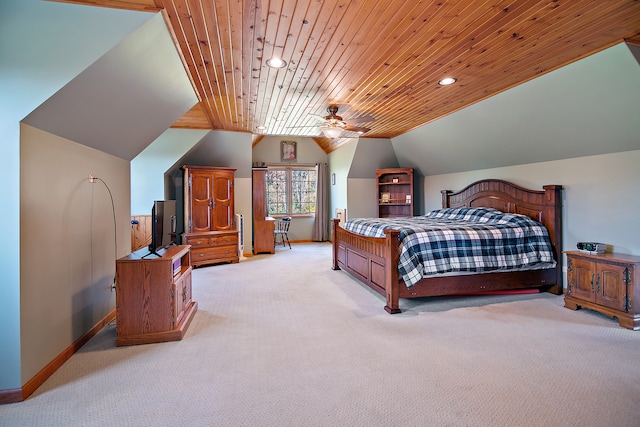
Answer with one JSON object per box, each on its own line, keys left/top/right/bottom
{"left": 0, "top": 243, "right": 640, "bottom": 426}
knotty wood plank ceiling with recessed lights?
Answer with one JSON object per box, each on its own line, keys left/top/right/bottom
{"left": 51, "top": 0, "right": 640, "bottom": 153}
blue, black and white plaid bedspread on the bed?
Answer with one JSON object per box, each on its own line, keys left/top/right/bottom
{"left": 345, "top": 208, "right": 556, "bottom": 288}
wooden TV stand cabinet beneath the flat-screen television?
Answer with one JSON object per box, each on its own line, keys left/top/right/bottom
{"left": 116, "top": 245, "right": 198, "bottom": 346}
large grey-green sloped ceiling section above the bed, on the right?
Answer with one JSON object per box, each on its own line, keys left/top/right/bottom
{"left": 392, "top": 43, "right": 640, "bottom": 176}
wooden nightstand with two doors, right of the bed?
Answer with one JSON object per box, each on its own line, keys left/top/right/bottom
{"left": 564, "top": 251, "right": 640, "bottom": 330}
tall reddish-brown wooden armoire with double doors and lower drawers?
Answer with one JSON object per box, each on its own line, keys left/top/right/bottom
{"left": 182, "top": 166, "right": 240, "bottom": 266}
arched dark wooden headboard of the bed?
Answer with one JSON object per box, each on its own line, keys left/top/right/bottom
{"left": 442, "top": 179, "right": 562, "bottom": 276}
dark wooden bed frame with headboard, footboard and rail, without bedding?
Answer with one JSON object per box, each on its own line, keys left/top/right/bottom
{"left": 332, "top": 179, "right": 562, "bottom": 314}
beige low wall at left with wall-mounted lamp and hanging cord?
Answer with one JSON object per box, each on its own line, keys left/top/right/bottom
{"left": 20, "top": 124, "right": 131, "bottom": 384}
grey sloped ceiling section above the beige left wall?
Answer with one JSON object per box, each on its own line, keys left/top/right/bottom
{"left": 24, "top": 14, "right": 197, "bottom": 160}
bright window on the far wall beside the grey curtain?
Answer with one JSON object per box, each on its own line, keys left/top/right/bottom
{"left": 267, "top": 166, "right": 316, "bottom": 215}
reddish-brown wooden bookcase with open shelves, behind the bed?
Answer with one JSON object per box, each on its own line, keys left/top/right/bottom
{"left": 376, "top": 168, "right": 413, "bottom": 218}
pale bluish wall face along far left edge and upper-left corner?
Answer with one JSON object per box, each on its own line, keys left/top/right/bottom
{"left": 0, "top": 0, "right": 153, "bottom": 390}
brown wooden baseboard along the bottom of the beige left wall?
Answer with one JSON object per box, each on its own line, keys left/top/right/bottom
{"left": 0, "top": 308, "right": 116, "bottom": 404}
